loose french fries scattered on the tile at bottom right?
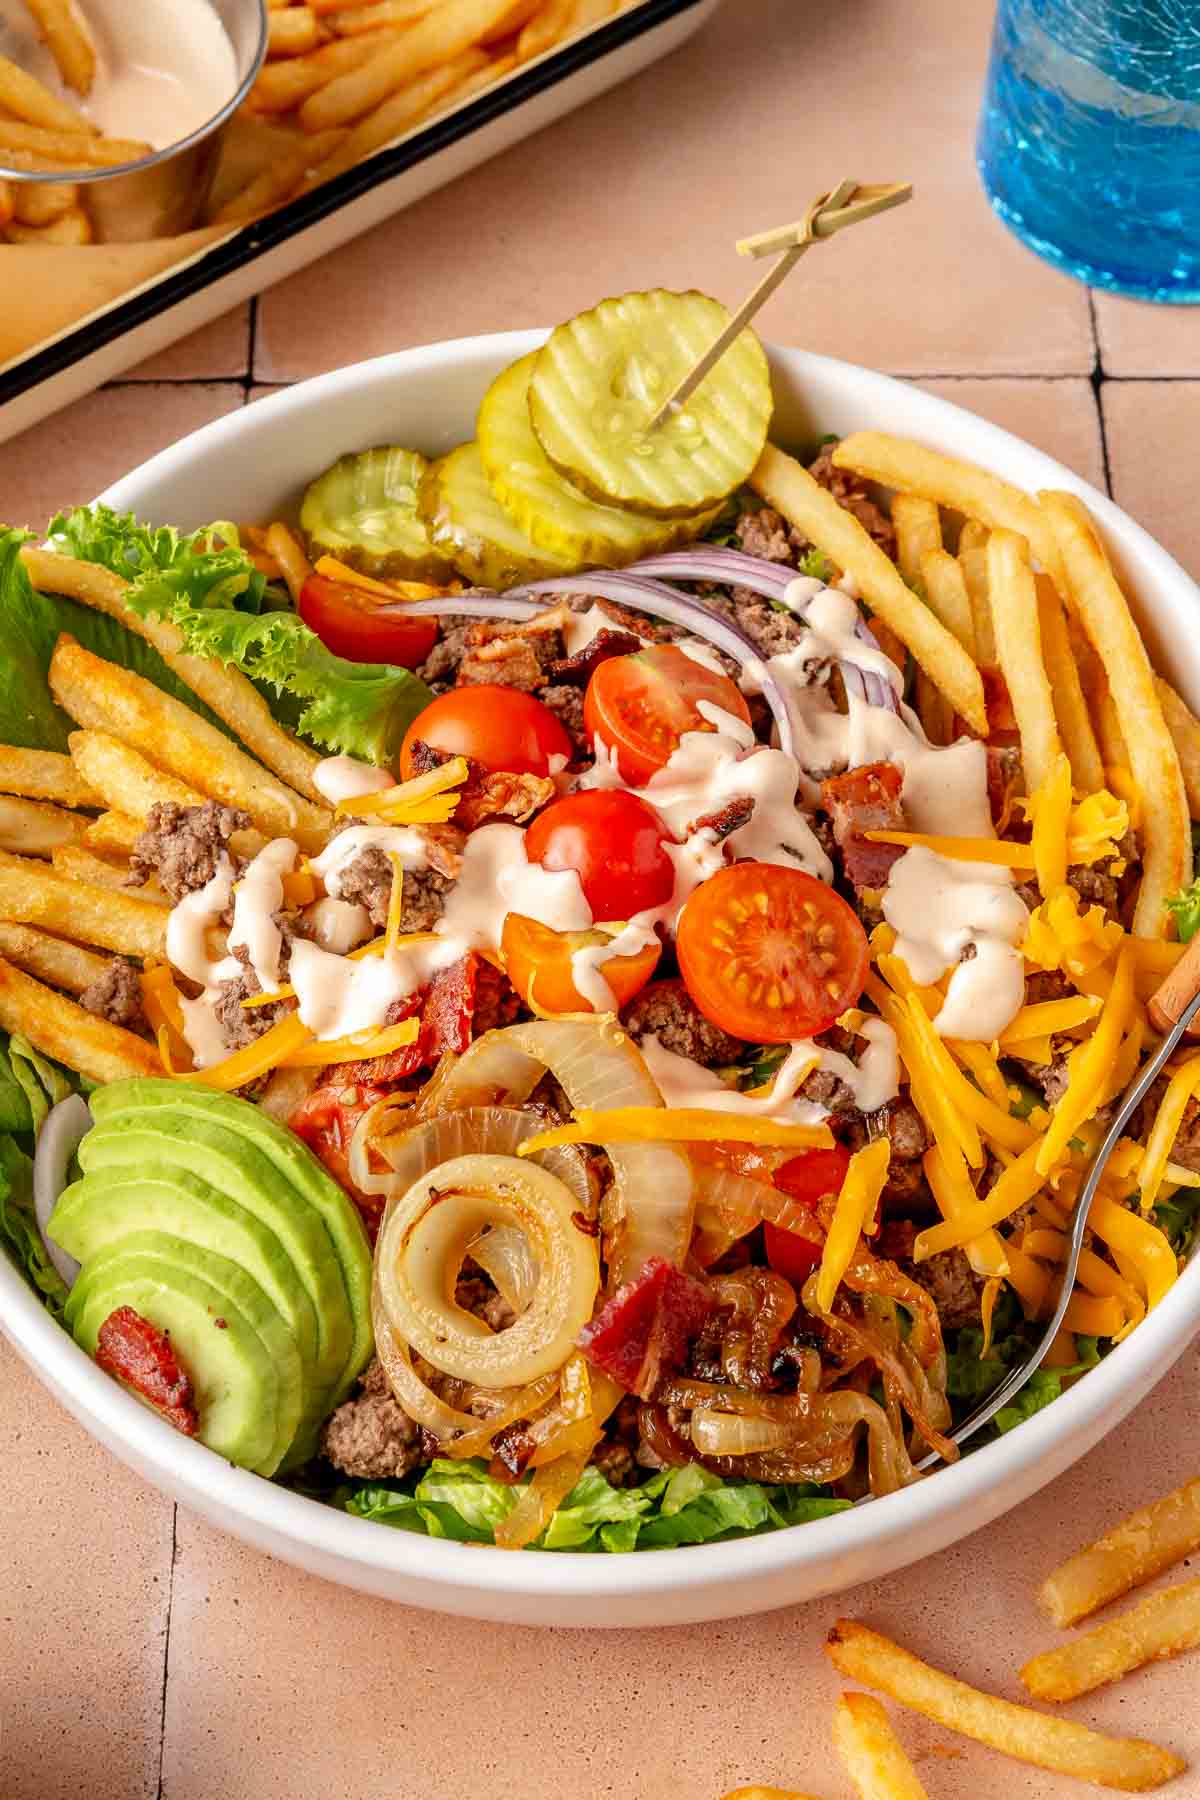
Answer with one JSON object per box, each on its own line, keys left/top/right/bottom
{"left": 725, "top": 1476, "right": 1200, "bottom": 1800}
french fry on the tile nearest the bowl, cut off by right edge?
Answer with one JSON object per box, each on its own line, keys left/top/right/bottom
{"left": 1038, "top": 1476, "right": 1200, "bottom": 1625}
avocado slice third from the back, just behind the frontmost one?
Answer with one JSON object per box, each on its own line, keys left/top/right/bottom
{"left": 52, "top": 1159, "right": 329, "bottom": 1460}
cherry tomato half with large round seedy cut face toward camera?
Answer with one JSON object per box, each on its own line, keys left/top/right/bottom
{"left": 675, "top": 862, "right": 869, "bottom": 1044}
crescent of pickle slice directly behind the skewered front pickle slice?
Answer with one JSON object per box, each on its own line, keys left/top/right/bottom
{"left": 479, "top": 351, "right": 714, "bottom": 569}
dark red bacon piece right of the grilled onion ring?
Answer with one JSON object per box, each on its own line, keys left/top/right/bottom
{"left": 576, "top": 1256, "right": 714, "bottom": 1400}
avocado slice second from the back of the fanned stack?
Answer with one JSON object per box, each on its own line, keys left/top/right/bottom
{"left": 62, "top": 1107, "right": 354, "bottom": 1463}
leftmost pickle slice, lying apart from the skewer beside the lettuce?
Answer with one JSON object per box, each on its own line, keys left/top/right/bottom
{"left": 300, "top": 445, "right": 453, "bottom": 581}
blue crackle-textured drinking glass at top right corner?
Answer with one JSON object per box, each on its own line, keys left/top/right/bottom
{"left": 977, "top": 0, "right": 1200, "bottom": 301}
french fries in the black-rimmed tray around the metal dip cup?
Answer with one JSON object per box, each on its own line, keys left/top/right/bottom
{"left": 0, "top": 0, "right": 639, "bottom": 245}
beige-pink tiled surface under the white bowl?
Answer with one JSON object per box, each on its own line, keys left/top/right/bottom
{"left": 0, "top": 0, "right": 1200, "bottom": 1800}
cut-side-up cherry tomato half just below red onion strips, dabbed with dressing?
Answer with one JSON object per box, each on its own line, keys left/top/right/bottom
{"left": 583, "top": 644, "right": 750, "bottom": 787}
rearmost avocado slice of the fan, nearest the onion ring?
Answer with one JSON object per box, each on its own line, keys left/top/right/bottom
{"left": 85, "top": 1076, "right": 374, "bottom": 1409}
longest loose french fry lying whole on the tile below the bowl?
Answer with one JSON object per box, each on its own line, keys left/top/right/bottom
{"left": 826, "top": 1618, "right": 1187, "bottom": 1793}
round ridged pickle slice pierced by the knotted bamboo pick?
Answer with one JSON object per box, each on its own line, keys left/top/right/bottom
{"left": 529, "top": 288, "right": 772, "bottom": 518}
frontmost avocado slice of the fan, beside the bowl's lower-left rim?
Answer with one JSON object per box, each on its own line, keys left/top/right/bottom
{"left": 65, "top": 1231, "right": 302, "bottom": 1474}
